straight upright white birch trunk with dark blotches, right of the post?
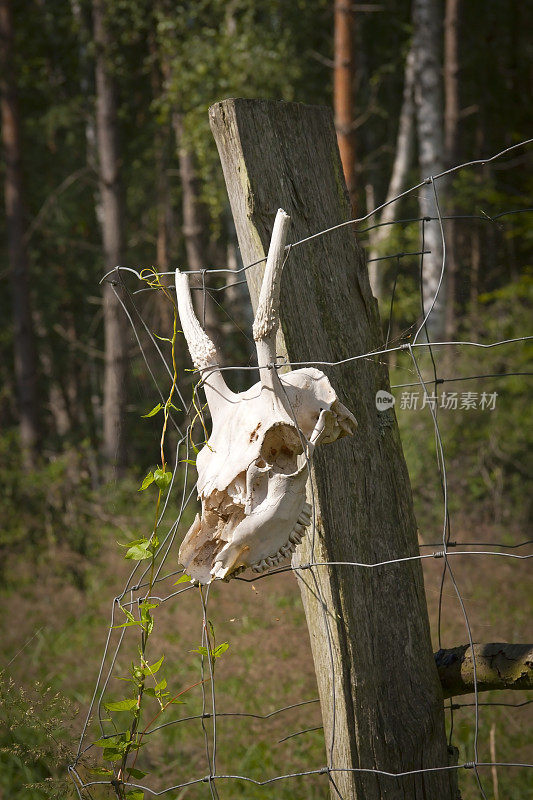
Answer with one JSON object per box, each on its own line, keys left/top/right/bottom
{"left": 413, "top": 0, "right": 446, "bottom": 340}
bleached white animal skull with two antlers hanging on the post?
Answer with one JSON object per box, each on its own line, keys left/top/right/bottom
{"left": 176, "top": 209, "right": 357, "bottom": 583}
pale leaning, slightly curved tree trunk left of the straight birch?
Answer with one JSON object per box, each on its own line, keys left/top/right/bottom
{"left": 368, "top": 40, "right": 415, "bottom": 300}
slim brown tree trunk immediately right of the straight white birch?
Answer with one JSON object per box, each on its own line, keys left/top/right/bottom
{"left": 444, "top": 0, "right": 461, "bottom": 340}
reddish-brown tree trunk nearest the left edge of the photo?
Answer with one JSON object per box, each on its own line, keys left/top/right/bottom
{"left": 0, "top": 0, "right": 39, "bottom": 468}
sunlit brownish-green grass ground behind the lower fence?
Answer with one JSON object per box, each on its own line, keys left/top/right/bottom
{"left": 0, "top": 488, "right": 533, "bottom": 800}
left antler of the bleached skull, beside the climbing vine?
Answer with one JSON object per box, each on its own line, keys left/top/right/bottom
{"left": 176, "top": 269, "right": 233, "bottom": 419}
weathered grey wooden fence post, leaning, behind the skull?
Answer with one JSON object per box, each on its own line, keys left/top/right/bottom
{"left": 210, "top": 100, "right": 455, "bottom": 800}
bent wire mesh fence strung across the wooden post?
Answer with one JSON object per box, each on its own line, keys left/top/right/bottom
{"left": 69, "top": 140, "right": 533, "bottom": 800}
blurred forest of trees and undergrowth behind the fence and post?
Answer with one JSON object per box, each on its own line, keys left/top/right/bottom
{"left": 0, "top": 0, "right": 533, "bottom": 800}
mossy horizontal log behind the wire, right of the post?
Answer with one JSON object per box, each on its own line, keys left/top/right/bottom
{"left": 435, "top": 642, "right": 533, "bottom": 698}
